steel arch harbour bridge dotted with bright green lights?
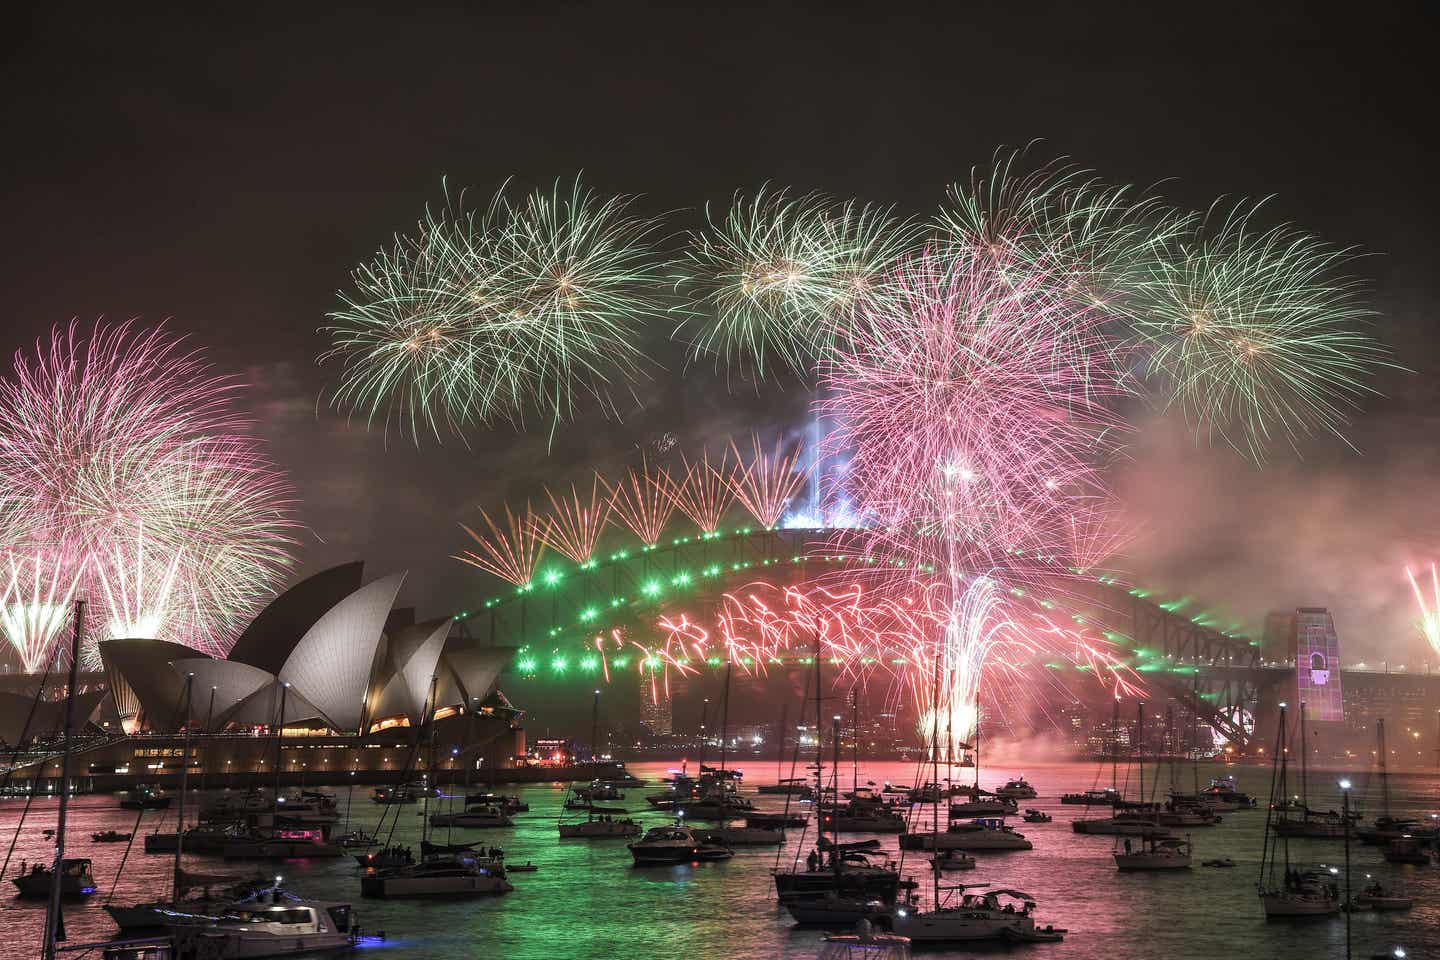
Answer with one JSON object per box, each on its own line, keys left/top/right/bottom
{"left": 456, "top": 527, "right": 1296, "bottom": 751}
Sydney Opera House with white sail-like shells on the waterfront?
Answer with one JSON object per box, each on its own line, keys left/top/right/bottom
{"left": 0, "top": 563, "right": 524, "bottom": 789}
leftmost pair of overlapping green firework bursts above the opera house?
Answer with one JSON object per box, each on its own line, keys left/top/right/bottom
{"left": 323, "top": 178, "right": 668, "bottom": 439}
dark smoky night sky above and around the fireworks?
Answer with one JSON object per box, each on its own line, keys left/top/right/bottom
{"left": 0, "top": 3, "right": 1440, "bottom": 664}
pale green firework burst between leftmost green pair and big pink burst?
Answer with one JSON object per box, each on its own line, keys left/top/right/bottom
{"left": 683, "top": 190, "right": 916, "bottom": 379}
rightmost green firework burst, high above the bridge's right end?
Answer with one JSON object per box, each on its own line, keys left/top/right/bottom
{"left": 1133, "top": 204, "right": 1385, "bottom": 461}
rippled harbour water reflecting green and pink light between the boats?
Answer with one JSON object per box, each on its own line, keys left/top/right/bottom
{"left": 0, "top": 761, "right": 1440, "bottom": 960}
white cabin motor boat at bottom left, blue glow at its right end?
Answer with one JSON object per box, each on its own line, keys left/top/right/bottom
{"left": 167, "top": 891, "right": 356, "bottom": 960}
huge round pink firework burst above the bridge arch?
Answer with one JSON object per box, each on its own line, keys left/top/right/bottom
{"left": 819, "top": 244, "right": 1122, "bottom": 576}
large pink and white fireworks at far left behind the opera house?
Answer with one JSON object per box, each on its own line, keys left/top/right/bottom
{"left": 0, "top": 324, "right": 294, "bottom": 668}
